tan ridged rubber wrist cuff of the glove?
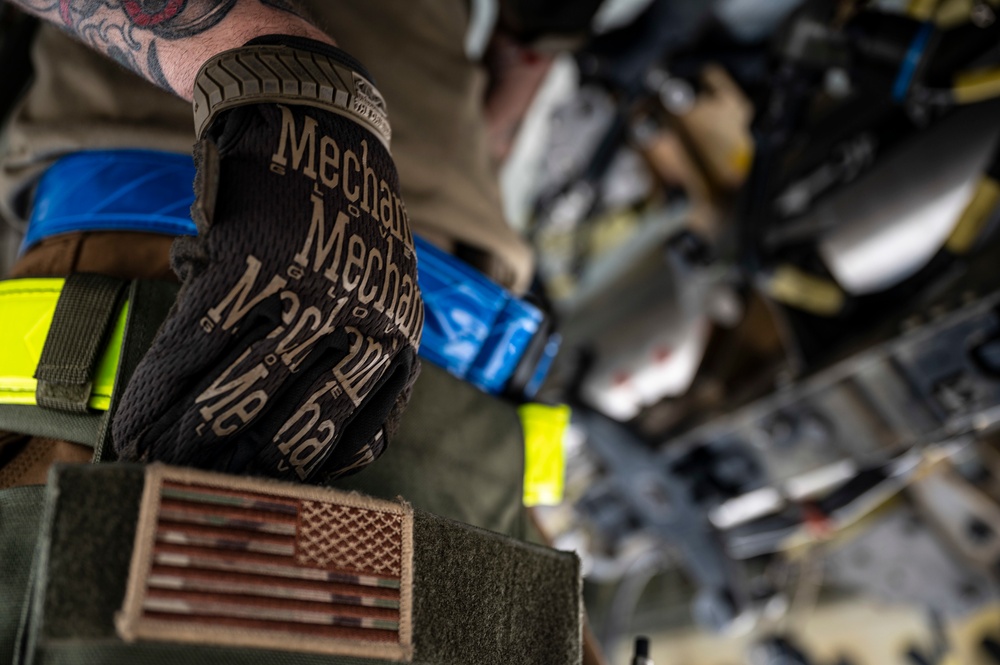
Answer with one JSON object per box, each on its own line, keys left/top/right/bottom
{"left": 194, "top": 35, "right": 392, "bottom": 150}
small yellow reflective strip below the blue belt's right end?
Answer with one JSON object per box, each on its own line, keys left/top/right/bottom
{"left": 517, "top": 404, "right": 571, "bottom": 507}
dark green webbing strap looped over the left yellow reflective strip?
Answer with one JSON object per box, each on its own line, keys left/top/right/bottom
{"left": 35, "top": 273, "right": 127, "bottom": 413}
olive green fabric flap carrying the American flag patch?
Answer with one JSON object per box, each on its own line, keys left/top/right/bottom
{"left": 15, "top": 464, "right": 581, "bottom": 665}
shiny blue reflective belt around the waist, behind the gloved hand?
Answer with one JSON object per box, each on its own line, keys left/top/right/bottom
{"left": 22, "top": 150, "right": 559, "bottom": 397}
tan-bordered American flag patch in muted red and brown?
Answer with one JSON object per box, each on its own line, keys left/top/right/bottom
{"left": 116, "top": 465, "right": 413, "bottom": 661}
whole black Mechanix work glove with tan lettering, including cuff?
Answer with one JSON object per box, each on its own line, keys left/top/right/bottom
{"left": 113, "top": 37, "right": 423, "bottom": 482}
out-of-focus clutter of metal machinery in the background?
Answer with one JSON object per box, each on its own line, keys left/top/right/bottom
{"left": 0, "top": 0, "right": 1000, "bottom": 665}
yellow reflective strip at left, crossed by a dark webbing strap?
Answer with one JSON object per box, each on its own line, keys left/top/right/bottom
{"left": 0, "top": 278, "right": 128, "bottom": 411}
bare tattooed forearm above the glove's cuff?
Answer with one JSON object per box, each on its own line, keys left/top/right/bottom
{"left": 12, "top": 0, "right": 334, "bottom": 101}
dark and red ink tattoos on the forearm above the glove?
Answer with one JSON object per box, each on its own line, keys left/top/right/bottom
{"left": 13, "top": 0, "right": 301, "bottom": 92}
